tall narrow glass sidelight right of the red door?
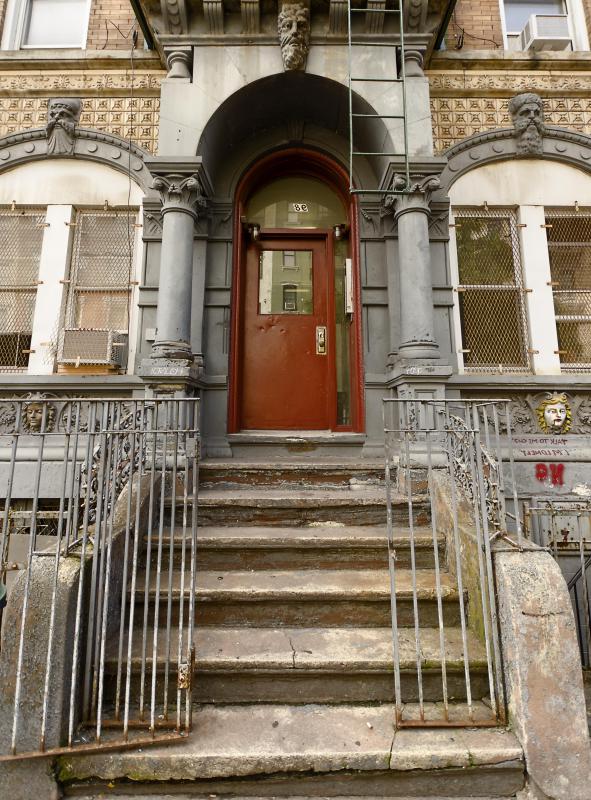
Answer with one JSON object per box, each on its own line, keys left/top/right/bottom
{"left": 335, "top": 241, "right": 351, "bottom": 425}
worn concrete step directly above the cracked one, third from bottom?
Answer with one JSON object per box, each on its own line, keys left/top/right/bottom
{"left": 136, "top": 569, "right": 460, "bottom": 627}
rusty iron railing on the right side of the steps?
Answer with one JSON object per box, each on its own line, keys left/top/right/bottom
{"left": 384, "top": 399, "right": 522, "bottom": 727}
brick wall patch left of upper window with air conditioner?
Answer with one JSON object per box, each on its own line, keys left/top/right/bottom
{"left": 446, "top": 0, "right": 504, "bottom": 50}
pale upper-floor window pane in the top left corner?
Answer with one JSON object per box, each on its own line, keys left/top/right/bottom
{"left": 22, "top": 0, "right": 88, "bottom": 47}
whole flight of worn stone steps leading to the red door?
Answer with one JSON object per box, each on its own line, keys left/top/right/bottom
{"left": 58, "top": 462, "right": 524, "bottom": 800}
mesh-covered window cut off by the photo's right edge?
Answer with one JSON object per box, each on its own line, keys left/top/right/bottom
{"left": 546, "top": 208, "right": 591, "bottom": 372}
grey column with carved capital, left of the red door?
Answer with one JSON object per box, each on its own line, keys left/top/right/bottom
{"left": 152, "top": 174, "right": 205, "bottom": 360}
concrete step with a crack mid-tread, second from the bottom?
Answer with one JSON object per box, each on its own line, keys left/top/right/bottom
{"left": 107, "top": 628, "right": 488, "bottom": 703}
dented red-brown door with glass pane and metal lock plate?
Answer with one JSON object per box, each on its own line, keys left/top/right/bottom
{"left": 240, "top": 235, "right": 335, "bottom": 430}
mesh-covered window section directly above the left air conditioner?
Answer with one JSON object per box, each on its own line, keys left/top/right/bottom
{"left": 65, "top": 209, "right": 136, "bottom": 331}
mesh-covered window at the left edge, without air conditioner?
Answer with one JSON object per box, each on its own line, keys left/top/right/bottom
{"left": 0, "top": 208, "right": 45, "bottom": 372}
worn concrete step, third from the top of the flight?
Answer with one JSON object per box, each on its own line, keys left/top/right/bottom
{"left": 146, "top": 523, "right": 445, "bottom": 570}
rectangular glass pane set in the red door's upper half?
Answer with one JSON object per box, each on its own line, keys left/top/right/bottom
{"left": 259, "top": 250, "right": 314, "bottom": 314}
